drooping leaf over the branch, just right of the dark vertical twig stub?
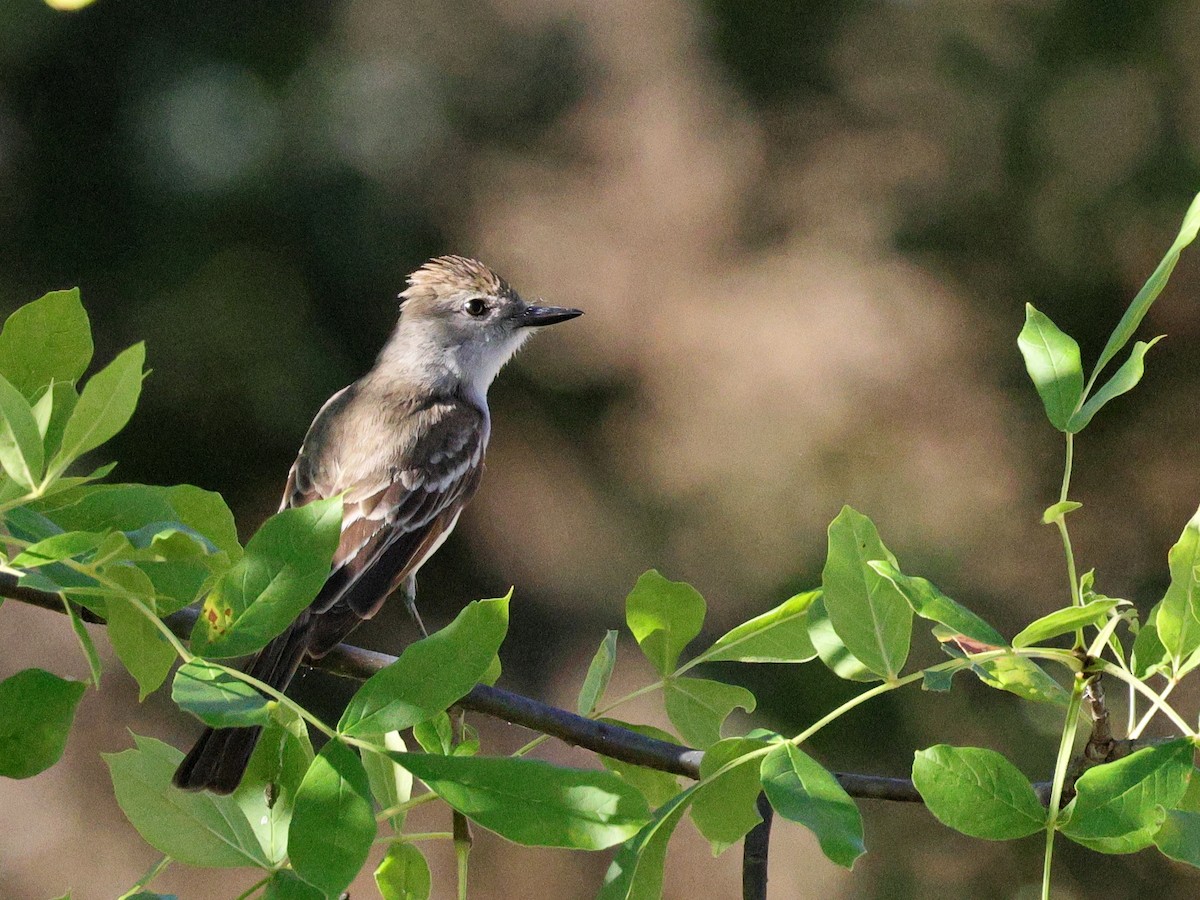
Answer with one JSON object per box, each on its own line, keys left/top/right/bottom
{"left": 760, "top": 744, "right": 866, "bottom": 869}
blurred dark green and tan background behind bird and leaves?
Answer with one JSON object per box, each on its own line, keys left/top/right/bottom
{"left": 0, "top": 0, "right": 1200, "bottom": 900}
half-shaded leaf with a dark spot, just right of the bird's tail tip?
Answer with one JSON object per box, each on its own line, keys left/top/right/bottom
{"left": 233, "top": 707, "right": 313, "bottom": 865}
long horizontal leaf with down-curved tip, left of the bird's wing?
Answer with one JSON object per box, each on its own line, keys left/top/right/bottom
{"left": 38, "top": 485, "right": 241, "bottom": 562}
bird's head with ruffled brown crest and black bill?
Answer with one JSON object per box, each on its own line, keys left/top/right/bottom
{"left": 384, "top": 256, "right": 582, "bottom": 395}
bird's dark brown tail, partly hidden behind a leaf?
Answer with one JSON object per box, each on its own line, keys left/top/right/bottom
{"left": 172, "top": 616, "right": 311, "bottom": 793}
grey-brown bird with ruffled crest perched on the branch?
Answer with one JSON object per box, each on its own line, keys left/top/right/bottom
{"left": 174, "top": 257, "right": 581, "bottom": 793}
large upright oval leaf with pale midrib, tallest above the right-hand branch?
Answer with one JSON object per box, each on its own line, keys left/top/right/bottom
{"left": 821, "top": 506, "right": 912, "bottom": 679}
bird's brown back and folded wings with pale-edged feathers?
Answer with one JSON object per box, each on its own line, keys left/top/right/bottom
{"left": 283, "top": 385, "right": 487, "bottom": 643}
